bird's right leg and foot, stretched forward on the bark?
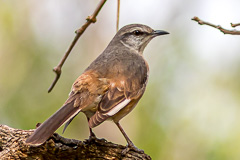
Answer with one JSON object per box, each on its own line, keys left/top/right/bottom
{"left": 115, "top": 122, "right": 144, "bottom": 154}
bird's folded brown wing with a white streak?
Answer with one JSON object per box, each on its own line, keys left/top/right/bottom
{"left": 89, "top": 80, "right": 146, "bottom": 128}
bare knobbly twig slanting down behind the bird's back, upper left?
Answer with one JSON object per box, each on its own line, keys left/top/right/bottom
{"left": 48, "top": 0, "right": 107, "bottom": 93}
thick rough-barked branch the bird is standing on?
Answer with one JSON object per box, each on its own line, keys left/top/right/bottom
{"left": 0, "top": 125, "right": 151, "bottom": 160}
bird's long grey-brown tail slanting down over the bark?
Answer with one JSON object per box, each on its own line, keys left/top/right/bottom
{"left": 26, "top": 100, "right": 80, "bottom": 145}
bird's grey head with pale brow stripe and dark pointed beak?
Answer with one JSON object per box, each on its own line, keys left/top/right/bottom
{"left": 113, "top": 24, "right": 169, "bottom": 54}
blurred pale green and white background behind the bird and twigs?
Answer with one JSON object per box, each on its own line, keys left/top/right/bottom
{"left": 0, "top": 0, "right": 240, "bottom": 160}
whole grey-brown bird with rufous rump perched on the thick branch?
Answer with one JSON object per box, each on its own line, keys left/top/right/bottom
{"left": 26, "top": 24, "right": 169, "bottom": 150}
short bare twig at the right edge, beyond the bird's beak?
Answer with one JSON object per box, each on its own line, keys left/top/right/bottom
{"left": 192, "top": 17, "right": 240, "bottom": 35}
